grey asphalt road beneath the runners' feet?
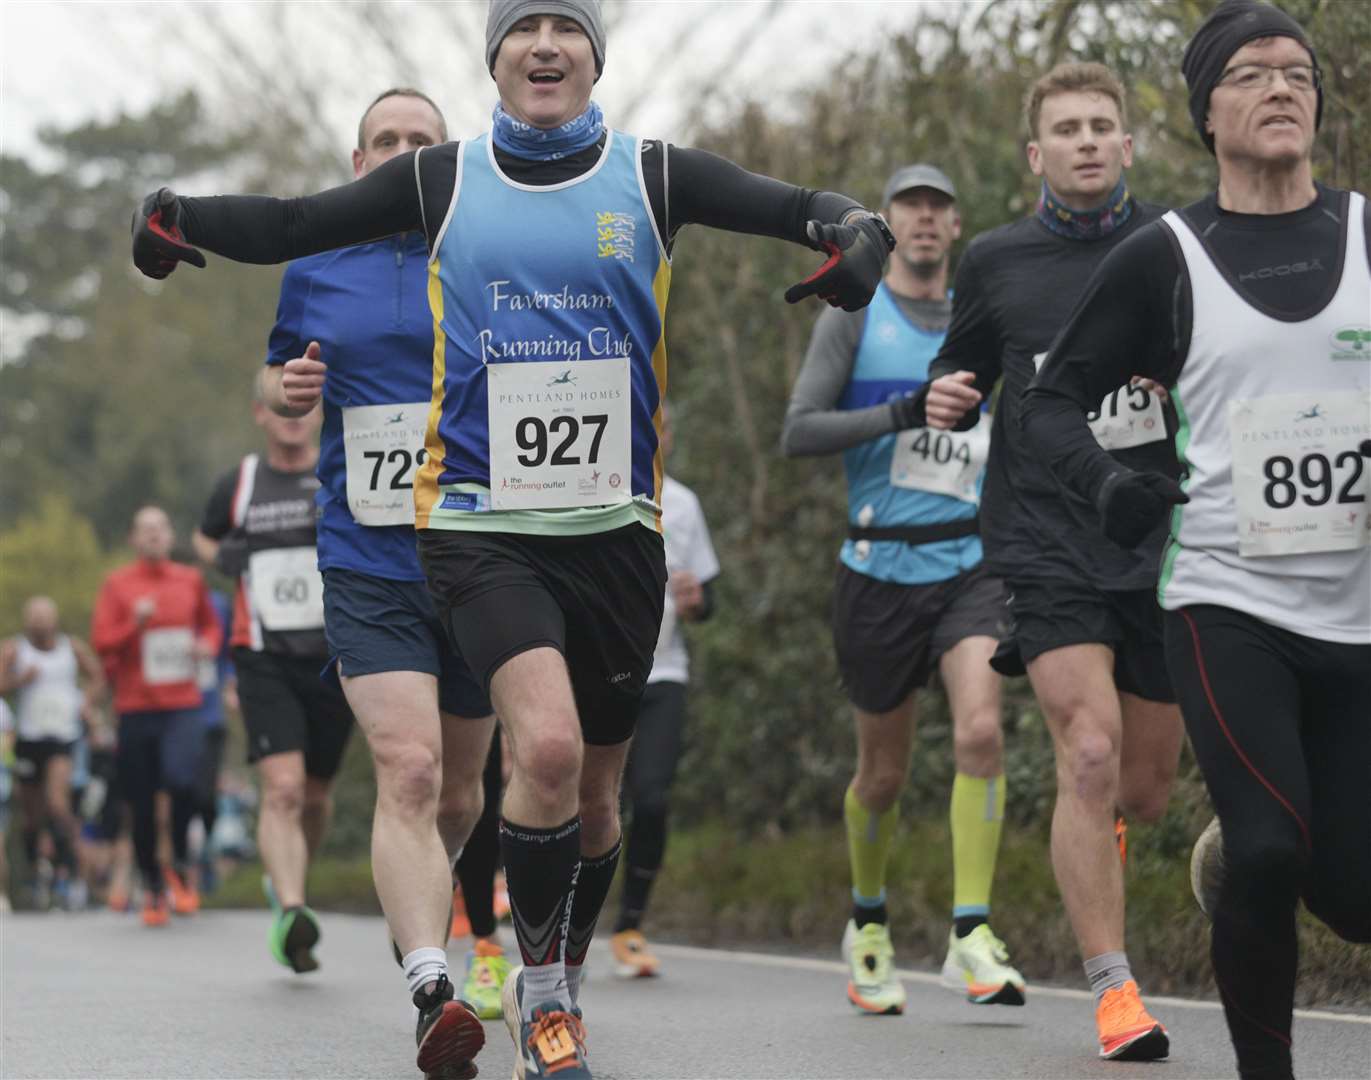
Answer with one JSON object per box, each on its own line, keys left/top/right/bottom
{"left": 0, "top": 911, "right": 1371, "bottom": 1080}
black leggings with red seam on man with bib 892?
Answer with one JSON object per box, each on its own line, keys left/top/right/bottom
{"left": 1167, "top": 606, "right": 1371, "bottom": 1080}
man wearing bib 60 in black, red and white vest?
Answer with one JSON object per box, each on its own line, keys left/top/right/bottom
{"left": 193, "top": 374, "right": 352, "bottom": 973}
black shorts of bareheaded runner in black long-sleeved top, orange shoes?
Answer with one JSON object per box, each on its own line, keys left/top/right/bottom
{"left": 993, "top": 578, "right": 1176, "bottom": 704}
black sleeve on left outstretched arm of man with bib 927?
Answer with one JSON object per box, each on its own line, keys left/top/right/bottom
{"left": 180, "top": 154, "right": 424, "bottom": 263}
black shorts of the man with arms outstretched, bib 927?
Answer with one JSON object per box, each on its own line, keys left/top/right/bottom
{"left": 418, "top": 525, "right": 666, "bottom": 746}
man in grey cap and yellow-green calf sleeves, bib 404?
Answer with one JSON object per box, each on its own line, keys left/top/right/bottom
{"left": 781, "top": 164, "right": 1024, "bottom": 1014}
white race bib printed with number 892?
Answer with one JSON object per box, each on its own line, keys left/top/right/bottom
{"left": 1228, "top": 391, "right": 1371, "bottom": 555}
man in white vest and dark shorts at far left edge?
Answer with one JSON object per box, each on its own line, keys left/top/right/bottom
{"left": 0, "top": 596, "right": 106, "bottom": 906}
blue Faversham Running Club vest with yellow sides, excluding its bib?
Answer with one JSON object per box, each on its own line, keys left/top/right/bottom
{"left": 414, "top": 132, "right": 670, "bottom": 536}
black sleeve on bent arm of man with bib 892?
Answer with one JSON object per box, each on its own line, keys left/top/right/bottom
{"left": 1020, "top": 222, "right": 1190, "bottom": 502}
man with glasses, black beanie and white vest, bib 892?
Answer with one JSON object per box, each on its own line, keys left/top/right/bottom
{"left": 1023, "top": 8, "right": 1371, "bottom": 1080}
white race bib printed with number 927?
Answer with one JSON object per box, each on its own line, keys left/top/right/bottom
{"left": 485, "top": 356, "right": 633, "bottom": 510}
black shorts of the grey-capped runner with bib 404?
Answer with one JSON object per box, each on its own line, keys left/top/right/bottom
{"left": 834, "top": 565, "right": 1006, "bottom": 713}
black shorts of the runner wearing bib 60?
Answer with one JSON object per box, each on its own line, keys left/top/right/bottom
{"left": 233, "top": 646, "right": 352, "bottom": 780}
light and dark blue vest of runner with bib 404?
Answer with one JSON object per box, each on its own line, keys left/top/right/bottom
{"left": 838, "top": 282, "right": 984, "bottom": 585}
